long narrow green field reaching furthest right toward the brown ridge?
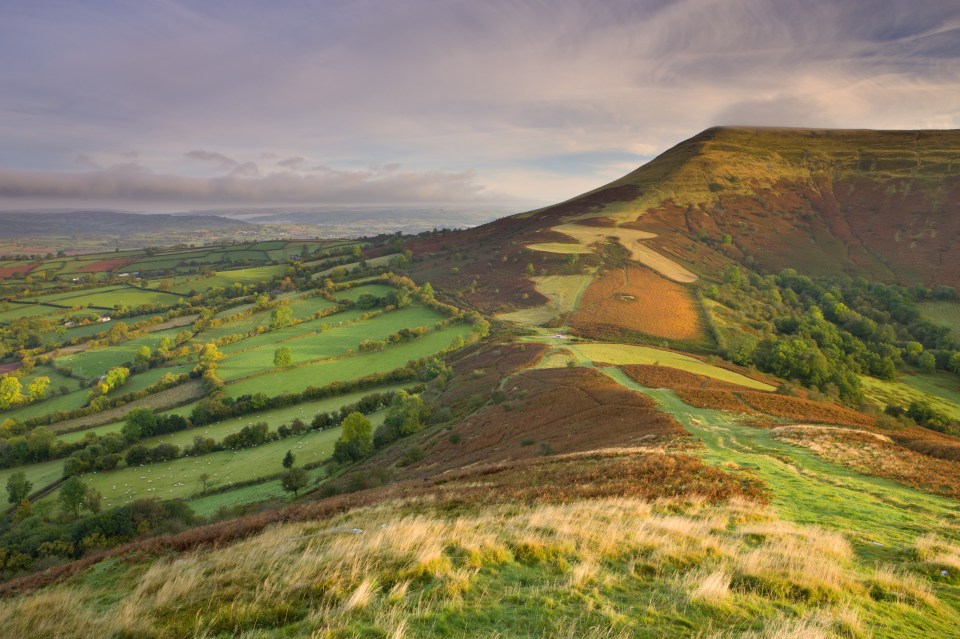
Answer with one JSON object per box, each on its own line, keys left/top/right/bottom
{"left": 226, "top": 324, "right": 472, "bottom": 397}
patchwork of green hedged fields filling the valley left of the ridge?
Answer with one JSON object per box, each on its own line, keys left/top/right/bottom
{"left": 0, "top": 232, "right": 480, "bottom": 528}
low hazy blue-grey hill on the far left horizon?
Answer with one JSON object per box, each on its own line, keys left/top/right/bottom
{"left": 0, "top": 211, "right": 249, "bottom": 238}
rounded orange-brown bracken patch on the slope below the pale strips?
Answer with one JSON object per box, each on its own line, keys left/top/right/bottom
{"left": 570, "top": 265, "right": 703, "bottom": 341}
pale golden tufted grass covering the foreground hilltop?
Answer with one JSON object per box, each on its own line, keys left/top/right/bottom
{"left": 0, "top": 499, "right": 955, "bottom": 639}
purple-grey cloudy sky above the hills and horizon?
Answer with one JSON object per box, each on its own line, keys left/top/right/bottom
{"left": 0, "top": 0, "right": 960, "bottom": 211}
